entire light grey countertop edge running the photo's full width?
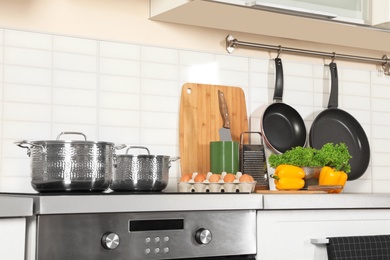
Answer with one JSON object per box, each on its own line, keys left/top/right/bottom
{"left": 0, "top": 193, "right": 390, "bottom": 214}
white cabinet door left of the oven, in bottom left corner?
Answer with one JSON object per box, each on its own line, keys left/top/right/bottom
{"left": 0, "top": 218, "right": 26, "bottom": 260}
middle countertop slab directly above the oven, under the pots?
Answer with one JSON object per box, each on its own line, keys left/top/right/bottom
{"left": 28, "top": 193, "right": 263, "bottom": 214}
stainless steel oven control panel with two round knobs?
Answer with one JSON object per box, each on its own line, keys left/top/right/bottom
{"left": 37, "top": 210, "right": 256, "bottom": 260}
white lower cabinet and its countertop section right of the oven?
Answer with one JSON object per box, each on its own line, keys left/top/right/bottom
{"left": 257, "top": 194, "right": 390, "bottom": 260}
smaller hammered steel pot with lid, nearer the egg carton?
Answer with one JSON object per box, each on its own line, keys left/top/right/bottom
{"left": 110, "top": 146, "right": 179, "bottom": 191}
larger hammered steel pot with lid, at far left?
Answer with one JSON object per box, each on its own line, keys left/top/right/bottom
{"left": 16, "top": 132, "right": 114, "bottom": 192}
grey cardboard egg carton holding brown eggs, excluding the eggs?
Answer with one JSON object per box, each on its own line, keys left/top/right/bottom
{"left": 178, "top": 172, "right": 256, "bottom": 193}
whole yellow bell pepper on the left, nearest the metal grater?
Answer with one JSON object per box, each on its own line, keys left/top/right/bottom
{"left": 271, "top": 164, "right": 305, "bottom": 190}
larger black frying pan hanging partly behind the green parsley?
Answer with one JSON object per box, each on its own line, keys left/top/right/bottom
{"left": 309, "top": 62, "right": 370, "bottom": 181}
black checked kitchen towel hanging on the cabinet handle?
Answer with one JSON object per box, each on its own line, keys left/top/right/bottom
{"left": 327, "top": 235, "right": 390, "bottom": 260}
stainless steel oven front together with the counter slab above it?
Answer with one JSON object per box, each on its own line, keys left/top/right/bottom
{"left": 19, "top": 193, "right": 262, "bottom": 260}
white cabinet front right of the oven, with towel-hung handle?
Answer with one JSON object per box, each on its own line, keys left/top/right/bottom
{"left": 257, "top": 209, "right": 390, "bottom": 260}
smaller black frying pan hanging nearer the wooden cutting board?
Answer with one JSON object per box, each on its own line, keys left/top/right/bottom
{"left": 261, "top": 58, "right": 306, "bottom": 153}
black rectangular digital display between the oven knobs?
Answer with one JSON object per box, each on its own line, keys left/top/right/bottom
{"left": 129, "top": 219, "right": 184, "bottom": 232}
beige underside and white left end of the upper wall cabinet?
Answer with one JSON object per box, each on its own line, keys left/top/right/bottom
{"left": 150, "top": 0, "right": 390, "bottom": 53}
